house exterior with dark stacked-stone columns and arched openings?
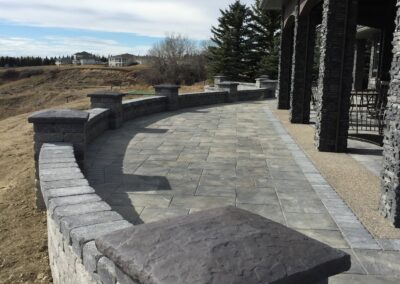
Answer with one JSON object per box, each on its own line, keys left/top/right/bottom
{"left": 262, "top": 0, "right": 400, "bottom": 227}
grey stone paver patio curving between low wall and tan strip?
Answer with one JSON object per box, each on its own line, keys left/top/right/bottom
{"left": 85, "top": 101, "right": 400, "bottom": 283}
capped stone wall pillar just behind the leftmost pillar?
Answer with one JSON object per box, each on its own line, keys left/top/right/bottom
{"left": 87, "top": 91, "right": 125, "bottom": 129}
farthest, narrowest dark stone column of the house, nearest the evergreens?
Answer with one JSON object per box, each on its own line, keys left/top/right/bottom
{"left": 277, "top": 19, "right": 293, "bottom": 109}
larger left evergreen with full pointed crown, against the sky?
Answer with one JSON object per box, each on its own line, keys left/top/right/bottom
{"left": 208, "top": 0, "right": 253, "bottom": 80}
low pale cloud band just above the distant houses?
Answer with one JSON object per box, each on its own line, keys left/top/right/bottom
{"left": 0, "top": 36, "right": 150, "bottom": 57}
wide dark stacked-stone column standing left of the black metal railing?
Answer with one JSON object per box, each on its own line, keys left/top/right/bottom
{"left": 314, "top": 0, "right": 358, "bottom": 152}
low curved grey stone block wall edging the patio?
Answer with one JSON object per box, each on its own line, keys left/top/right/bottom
{"left": 29, "top": 81, "right": 276, "bottom": 283}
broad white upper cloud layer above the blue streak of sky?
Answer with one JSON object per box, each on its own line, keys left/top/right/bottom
{"left": 0, "top": 0, "right": 254, "bottom": 39}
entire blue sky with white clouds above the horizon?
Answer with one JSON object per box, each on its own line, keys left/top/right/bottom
{"left": 0, "top": 0, "right": 254, "bottom": 56}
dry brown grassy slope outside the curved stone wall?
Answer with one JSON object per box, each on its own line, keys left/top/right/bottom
{"left": 0, "top": 67, "right": 204, "bottom": 283}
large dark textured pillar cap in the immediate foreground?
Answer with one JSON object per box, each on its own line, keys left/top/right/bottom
{"left": 96, "top": 207, "right": 350, "bottom": 284}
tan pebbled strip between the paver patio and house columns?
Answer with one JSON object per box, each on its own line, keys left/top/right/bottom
{"left": 271, "top": 103, "right": 400, "bottom": 239}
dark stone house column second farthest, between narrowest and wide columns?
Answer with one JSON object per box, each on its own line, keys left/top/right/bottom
{"left": 289, "top": 6, "right": 317, "bottom": 123}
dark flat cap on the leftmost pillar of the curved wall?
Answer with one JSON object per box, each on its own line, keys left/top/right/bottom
{"left": 28, "top": 109, "right": 89, "bottom": 123}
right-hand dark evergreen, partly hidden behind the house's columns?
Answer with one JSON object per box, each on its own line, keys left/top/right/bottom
{"left": 252, "top": 0, "right": 281, "bottom": 79}
